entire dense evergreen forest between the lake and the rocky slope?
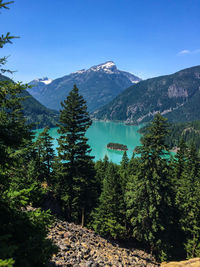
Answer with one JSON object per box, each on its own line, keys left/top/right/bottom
{"left": 0, "top": 0, "right": 200, "bottom": 266}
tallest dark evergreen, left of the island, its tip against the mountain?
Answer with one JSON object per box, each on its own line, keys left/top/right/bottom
{"left": 58, "top": 85, "right": 95, "bottom": 225}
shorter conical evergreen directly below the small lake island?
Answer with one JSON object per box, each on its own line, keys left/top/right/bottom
{"left": 92, "top": 163, "right": 126, "bottom": 239}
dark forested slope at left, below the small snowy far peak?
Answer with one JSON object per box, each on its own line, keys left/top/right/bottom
{"left": 0, "top": 74, "right": 59, "bottom": 128}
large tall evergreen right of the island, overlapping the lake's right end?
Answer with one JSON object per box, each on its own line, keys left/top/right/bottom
{"left": 126, "top": 114, "right": 174, "bottom": 260}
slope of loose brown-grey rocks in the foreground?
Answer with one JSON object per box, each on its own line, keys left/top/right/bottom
{"left": 49, "top": 221, "right": 159, "bottom": 267}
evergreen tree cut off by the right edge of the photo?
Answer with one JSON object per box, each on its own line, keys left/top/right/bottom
{"left": 175, "top": 145, "right": 200, "bottom": 258}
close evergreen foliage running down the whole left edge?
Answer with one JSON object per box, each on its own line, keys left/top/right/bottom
{"left": 0, "top": 0, "right": 56, "bottom": 266}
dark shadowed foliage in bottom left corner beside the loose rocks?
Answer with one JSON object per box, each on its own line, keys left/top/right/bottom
{"left": 0, "top": 201, "right": 56, "bottom": 266}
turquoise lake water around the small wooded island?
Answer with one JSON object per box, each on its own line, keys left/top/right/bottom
{"left": 36, "top": 121, "right": 143, "bottom": 163}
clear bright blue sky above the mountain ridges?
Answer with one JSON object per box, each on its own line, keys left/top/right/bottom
{"left": 0, "top": 0, "right": 200, "bottom": 82}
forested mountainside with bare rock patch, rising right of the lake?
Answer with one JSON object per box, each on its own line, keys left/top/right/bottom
{"left": 93, "top": 66, "right": 200, "bottom": 123}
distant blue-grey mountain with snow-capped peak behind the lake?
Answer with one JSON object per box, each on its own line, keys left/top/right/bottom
{"left": 29, "top": 61, "right": 141, "bottom": 112}
